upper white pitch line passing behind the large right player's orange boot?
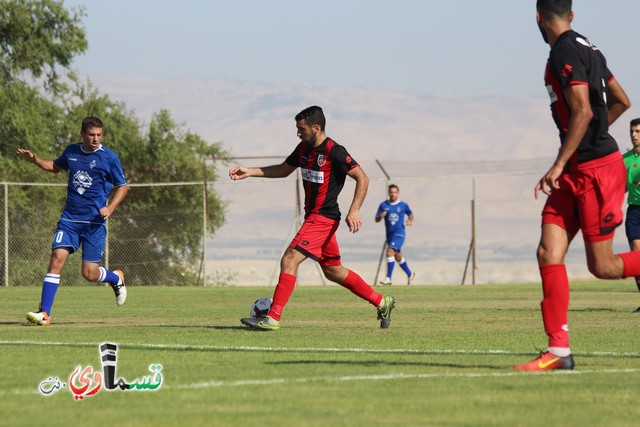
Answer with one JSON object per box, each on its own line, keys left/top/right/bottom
{"left": 0, "top": 341, "right": 640, "bottom": 358}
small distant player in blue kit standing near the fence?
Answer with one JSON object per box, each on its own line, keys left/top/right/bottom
{"left": 376, "top": 184, "right": 416, "bottom": 285}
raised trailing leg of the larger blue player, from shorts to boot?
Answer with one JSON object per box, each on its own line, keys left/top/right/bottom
{"left": 80, "top": 224, "right": 127, "bottom": 305}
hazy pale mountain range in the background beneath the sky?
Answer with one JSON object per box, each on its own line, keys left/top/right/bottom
{"left": 87, "top": 76, "right": 631, "bottom": 284}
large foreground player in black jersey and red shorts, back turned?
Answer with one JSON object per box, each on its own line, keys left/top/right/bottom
{"left": 514, "top": 0, "right": 640, "bottom": 371}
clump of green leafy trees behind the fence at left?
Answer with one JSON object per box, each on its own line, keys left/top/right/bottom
{"left": 0, "top": 0, "right": 226, "bottom": 284}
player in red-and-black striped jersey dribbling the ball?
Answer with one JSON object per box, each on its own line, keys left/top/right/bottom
{"left": 229, "top": 106, "right": 395, "bottom": 330}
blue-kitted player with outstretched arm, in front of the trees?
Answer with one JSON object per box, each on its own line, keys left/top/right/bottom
{"left": 17, "top": 117, "right": 129, "bottom": 326}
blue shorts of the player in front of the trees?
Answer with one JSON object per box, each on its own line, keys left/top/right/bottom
{"left": 51, "top": 220, "right": 107, "bottom": 262}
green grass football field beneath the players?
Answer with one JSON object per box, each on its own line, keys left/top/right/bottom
{"left": 0, "top": 281, "right": 640, "bottom": 427}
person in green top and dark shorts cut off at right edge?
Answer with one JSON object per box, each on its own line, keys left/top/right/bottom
{"left": 622, "top": 118, "right": 640, "bottom": 313}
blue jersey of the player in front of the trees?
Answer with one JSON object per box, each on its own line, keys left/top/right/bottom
{"left": 54, "top": 143, "right": 127, "bottom": 224}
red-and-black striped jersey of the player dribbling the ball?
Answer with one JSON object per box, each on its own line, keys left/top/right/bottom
{"left": 286, "top": 138, "right": 359, "bottom": 219}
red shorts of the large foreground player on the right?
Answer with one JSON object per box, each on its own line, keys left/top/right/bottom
{"left": 542, "top": 151, "right": 627, "bottom": 243}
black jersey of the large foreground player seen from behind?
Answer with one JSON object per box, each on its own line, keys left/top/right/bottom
{"left": 544, "top": 30, "right": 618, "bottom": 163}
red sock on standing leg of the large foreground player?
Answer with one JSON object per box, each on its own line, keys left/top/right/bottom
{"left": 540, "top": 264, "right": 569, "bottom": 348}
